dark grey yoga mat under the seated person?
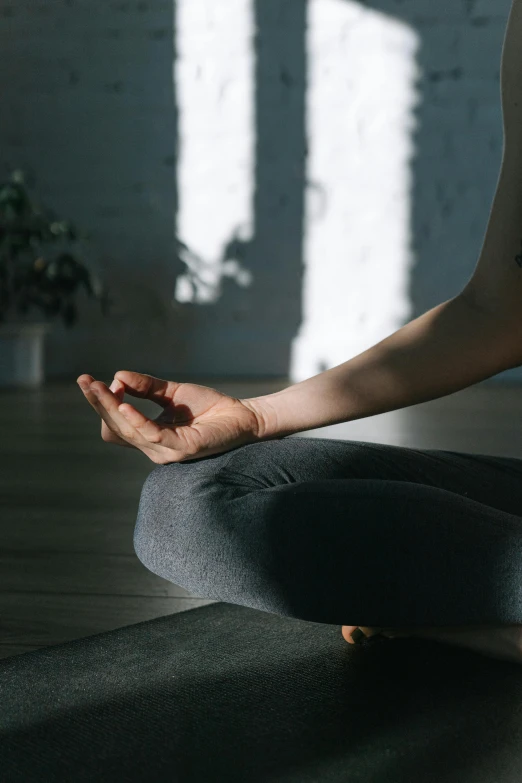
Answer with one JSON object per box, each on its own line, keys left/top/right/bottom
{"left": 0, "top": 603, "right": 522, "bottom": 783}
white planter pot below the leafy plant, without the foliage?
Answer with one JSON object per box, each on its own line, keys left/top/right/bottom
{"left": 0, "top": 322, "right": 52, "bottom": 387}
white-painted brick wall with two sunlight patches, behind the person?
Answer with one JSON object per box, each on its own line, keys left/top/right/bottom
{"left": 0, "top": 0, "right": 517, "bottom": 381}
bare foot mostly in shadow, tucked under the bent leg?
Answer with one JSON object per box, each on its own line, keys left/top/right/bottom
{"left": 342, "top": 625, "right": 522, "bottom": 663}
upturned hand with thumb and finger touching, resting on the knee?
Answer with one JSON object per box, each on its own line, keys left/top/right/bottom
{"left": 77, "top": 370, "right": 264, "bottom": 465}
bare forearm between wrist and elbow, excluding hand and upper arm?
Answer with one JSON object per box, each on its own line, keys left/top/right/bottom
{"left": 245, "top": 296, "right": 522, "bottom": 439}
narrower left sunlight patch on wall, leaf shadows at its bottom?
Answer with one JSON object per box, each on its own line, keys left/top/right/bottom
{"left": 174, "top": 0, "right": 255, "bottom": 304}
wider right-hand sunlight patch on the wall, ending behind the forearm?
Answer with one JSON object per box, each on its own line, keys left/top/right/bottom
{"left": 290, "top": 0, "right": 419, "bottom": 382}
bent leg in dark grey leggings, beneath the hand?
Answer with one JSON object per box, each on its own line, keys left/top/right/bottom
{"left": 134, "top": 436, "right": 522, "bottom": 627}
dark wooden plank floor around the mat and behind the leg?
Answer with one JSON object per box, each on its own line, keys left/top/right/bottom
{"left": 0, "top": 378, "right": 522, "bottom": 658}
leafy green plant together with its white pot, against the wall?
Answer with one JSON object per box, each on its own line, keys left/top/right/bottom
{"left": 0, "top": 170, "right": 111, "bottom": 386}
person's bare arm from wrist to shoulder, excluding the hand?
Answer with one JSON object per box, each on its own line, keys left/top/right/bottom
{"left": 244, "top": 0, "right": 522, "bottom": 438}
